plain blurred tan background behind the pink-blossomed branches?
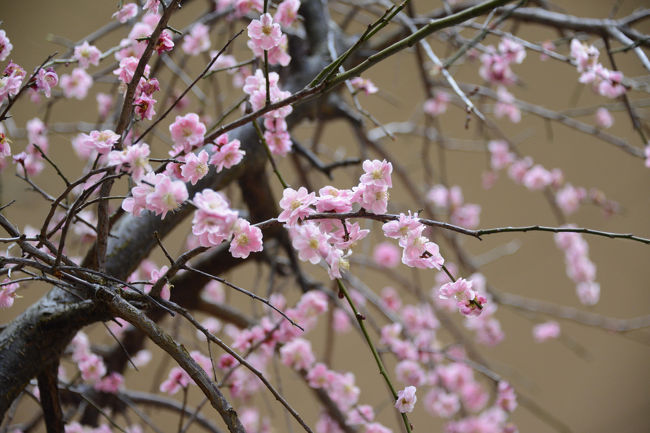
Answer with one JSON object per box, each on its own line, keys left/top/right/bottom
{"left": 0, "top": 0, "right": 650, "bottom": 433}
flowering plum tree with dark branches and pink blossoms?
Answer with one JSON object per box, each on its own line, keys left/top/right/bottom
{"left": 0, "top": 0, "right": 650, "bottom": 433}
